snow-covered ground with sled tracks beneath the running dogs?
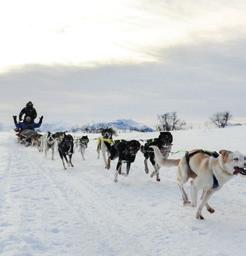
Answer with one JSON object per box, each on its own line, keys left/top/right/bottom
{"left": 0, "top": 126, "right": 246, "bottom": 256}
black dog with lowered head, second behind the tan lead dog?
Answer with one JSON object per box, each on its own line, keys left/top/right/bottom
{"left": 104, "top": 140, "right": 140, "bottom": 182}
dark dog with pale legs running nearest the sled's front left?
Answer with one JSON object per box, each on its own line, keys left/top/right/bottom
{"left": 58, "top": 134, "right": 74, "bottom": 170}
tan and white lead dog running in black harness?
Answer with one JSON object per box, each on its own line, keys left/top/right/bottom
{"left": 152, "top": 146, "right": 246, "bottom": 219}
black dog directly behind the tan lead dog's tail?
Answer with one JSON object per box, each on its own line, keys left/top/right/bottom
{"left": 141, "top": 132, "right": 173, "bottom": 181}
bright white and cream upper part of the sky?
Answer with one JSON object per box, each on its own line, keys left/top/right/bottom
{"left": 0, "top": 0, "right": 246, "bottom": 70}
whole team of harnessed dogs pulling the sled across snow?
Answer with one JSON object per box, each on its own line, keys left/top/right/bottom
{"left": 17, "top": 128, "right": 246, "bottom": 219}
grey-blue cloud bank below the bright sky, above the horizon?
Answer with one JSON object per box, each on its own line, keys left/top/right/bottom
{"left": 0, "top": 33, "right": 246, "bottom": 127}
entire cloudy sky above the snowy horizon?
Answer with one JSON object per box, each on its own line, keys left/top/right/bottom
{"left": 0, "top": 0, "right": 246, "bottom": 126}
